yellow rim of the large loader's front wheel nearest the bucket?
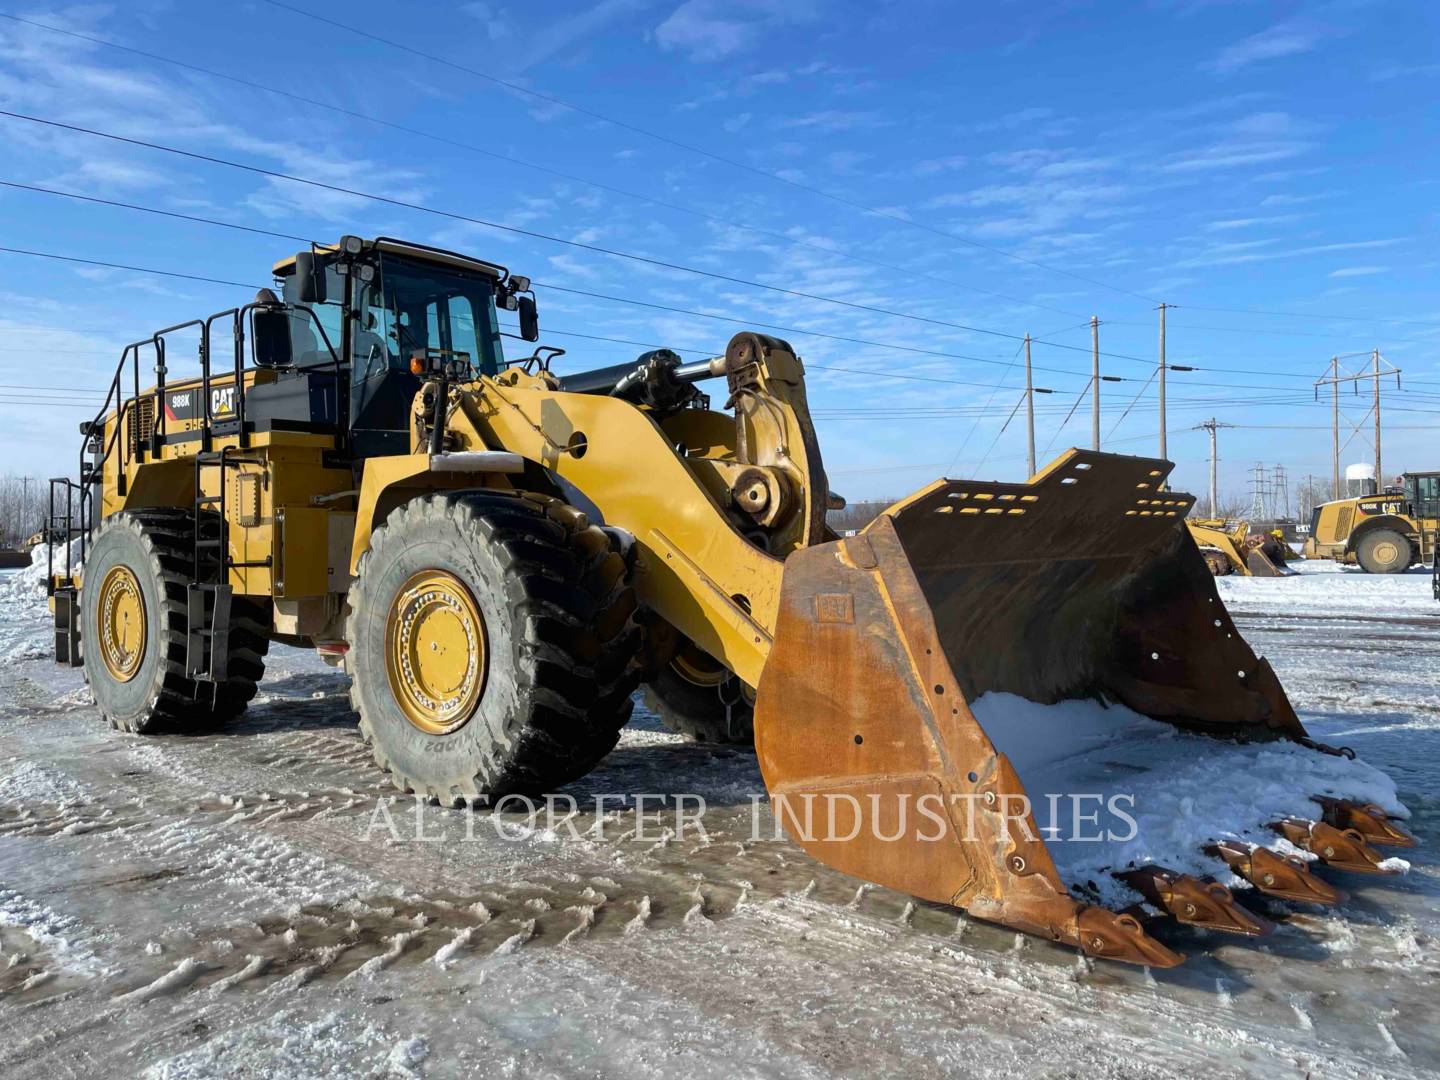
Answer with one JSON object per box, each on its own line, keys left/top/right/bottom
{"left": 384, "top": 570, "right": 487, "bottom": 734}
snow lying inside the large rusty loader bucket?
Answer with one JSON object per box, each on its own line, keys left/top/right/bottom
{"left": 972, "top": 694, "right": 1408, "bottom": 907}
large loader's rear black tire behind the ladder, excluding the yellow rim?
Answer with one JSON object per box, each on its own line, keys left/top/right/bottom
{"left": 81, "top": 510, "right": 269, "bottom": 734}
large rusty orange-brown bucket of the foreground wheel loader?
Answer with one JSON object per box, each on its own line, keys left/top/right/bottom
{"left": 755, "top": 451, "right": 1306, "bottom": 966}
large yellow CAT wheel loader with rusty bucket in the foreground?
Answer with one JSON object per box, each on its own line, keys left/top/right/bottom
{"left": 42, "top": 236, "right": 1408, "bottom": 966}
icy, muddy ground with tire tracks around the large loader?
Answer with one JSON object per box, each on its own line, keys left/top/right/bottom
{"left": 0, "top": 563, "right": 1440, "bottom": 1079}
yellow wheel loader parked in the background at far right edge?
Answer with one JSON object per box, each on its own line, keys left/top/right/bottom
{"left": 1305, "top": 472, "right": 1440, "bottom": 573}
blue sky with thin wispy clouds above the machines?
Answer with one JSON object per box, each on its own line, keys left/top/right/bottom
{"left": 0, "top": 0, "right": 1440, "bottom": 509}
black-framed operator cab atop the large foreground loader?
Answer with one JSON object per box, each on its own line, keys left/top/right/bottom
{"left": 267, "top": 236, "right": 536, "bottom": 456}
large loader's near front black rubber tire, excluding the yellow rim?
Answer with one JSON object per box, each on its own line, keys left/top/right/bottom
{"left": 346, "top": 490, "right": 639, "bottom": 806}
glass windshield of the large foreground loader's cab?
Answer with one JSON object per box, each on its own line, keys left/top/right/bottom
{"left": 354, "top": 255, "right": 504, "bottom": 380}
